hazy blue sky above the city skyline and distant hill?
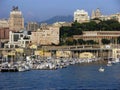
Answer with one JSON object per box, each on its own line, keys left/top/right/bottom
{"left": 0, "top": 0, "right": 120, "bottom": 21}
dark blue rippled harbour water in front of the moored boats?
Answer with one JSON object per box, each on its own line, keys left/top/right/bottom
{"left": 0, "top": 63, "right": 120, "bottom": 90}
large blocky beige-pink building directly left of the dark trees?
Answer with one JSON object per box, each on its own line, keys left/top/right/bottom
{"left": 31, "top": 26, "right": 59, "bottom": 45}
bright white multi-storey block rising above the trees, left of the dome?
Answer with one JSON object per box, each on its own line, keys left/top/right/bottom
{"left": 74, "top": 9, "right": 90, "bottom": 23}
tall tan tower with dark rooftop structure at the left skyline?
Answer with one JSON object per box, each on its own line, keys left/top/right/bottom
{"left": 9, "top": 6, "right": 24, "bottom": 32}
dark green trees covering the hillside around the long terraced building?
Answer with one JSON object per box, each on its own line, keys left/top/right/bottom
{"left": 60, "top": 19, "right": 120, "bottom": 45}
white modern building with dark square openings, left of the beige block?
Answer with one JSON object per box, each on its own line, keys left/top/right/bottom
{"left": 5, "top": 31, "right": 31, "bottom": 48}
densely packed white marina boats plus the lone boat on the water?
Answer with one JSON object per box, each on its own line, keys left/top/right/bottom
{"left": 0, "top": 56, "right": 120, "bottom": 72}
